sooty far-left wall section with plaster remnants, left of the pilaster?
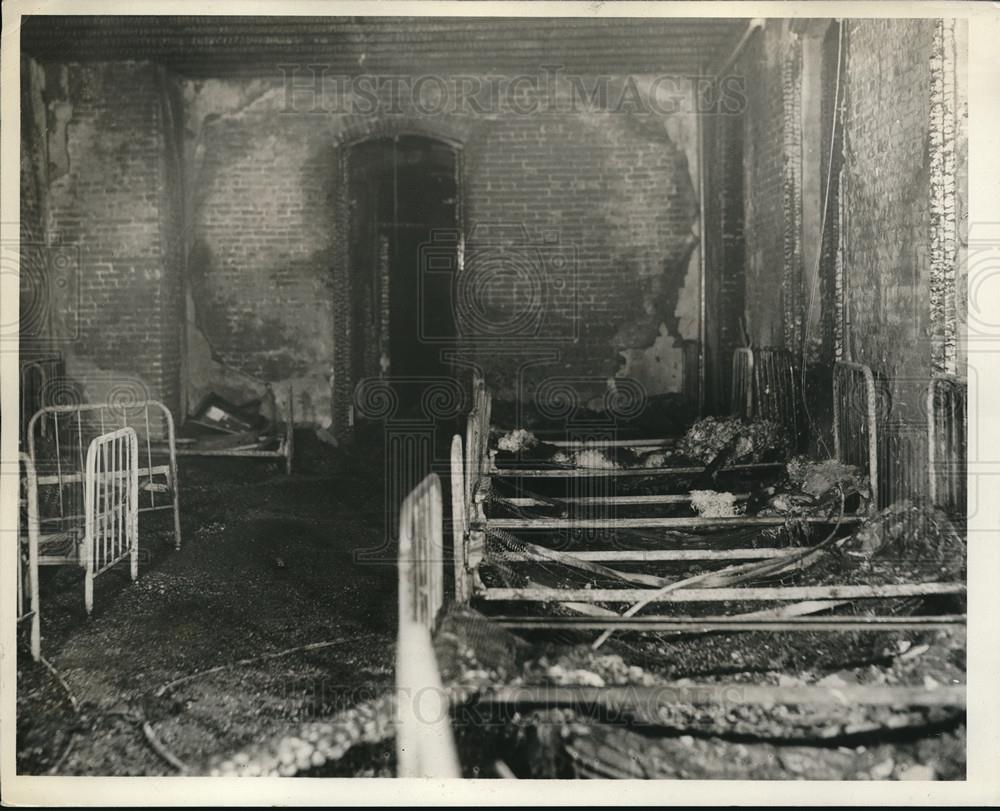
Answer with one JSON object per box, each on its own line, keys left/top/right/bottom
{"left": 21, "top": 62, "right": 183, "bottom": 409}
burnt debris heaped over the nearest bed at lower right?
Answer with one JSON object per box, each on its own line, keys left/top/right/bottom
{"left": 435, "top": 610, "right": 965, "bottom": 779}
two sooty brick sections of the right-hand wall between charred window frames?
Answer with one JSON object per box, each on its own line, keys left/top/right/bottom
{"left": 739, "top": 20, "right": 952, "bottom": 408}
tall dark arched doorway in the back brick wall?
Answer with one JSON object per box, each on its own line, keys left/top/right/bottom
{"left": 349, "top": 135, "right": 459, "bottom": 394}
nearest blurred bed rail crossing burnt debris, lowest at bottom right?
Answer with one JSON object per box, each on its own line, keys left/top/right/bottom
{"left": 478, "top": 682, "right": 966, "bottom": 714}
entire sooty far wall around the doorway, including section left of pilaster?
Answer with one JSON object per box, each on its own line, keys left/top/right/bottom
{"left": 22, "top": 62, "right": 699, "bottom": 424}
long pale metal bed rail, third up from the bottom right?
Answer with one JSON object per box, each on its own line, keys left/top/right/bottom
{"left": 478, "top": 583, "right": 965, "bottom": 603}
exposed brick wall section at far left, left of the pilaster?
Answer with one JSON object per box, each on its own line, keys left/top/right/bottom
{"left": 46, "top": 63, "right": 186, "bottom": 410}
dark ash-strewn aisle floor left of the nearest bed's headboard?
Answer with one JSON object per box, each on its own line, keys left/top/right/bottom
{"left": 17, "top": 435, "right": 397, "bottom": 775}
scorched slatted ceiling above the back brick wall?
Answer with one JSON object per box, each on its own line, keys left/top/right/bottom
{"left": 22, "top": 16, "right": 746, "bottom": 77}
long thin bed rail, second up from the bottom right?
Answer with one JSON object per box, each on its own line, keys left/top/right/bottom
{"left": 490, "top": 614, "right": 966, "bottom": 632}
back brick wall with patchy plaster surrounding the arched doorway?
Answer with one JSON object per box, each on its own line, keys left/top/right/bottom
{"left": 184, "top": 74, "right": 697, "bottom": 420}
